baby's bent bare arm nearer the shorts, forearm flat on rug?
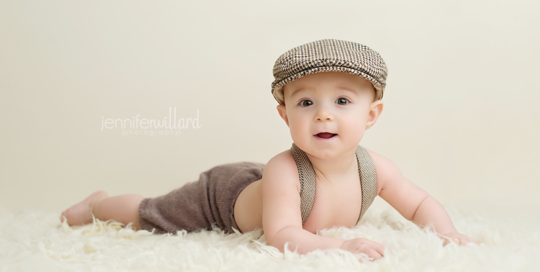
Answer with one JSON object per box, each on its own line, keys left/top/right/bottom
{"left": 262, "top": 151, "right": 384, "bottom": 259}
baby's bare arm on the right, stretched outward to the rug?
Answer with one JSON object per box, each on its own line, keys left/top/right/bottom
{"left": 368, "top": 150, "right": 476, "bottom": 245}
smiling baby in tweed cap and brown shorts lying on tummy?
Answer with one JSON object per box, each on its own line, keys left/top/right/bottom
{"left": 60, "top": 39, "right": 476, "bottom": 259}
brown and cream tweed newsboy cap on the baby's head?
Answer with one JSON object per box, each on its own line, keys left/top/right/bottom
{"left": 272, "top": 39, "right": 388, "bottom": 104}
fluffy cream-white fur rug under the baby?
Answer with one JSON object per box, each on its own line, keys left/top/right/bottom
{"left": 0, "top": 201, "right": 540, "bottom": 272}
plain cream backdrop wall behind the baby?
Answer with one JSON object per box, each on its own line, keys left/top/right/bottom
{"left": 0, "top": 0, "right": 540, "bottom": 216}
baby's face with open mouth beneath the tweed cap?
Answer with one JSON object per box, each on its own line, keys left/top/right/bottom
{"left": 278, "top": 72, "right": 382, "bottom": 158}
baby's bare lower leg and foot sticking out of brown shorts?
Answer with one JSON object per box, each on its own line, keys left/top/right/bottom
{"left": 60, "top": 191, "right": 144, "bottom": 230}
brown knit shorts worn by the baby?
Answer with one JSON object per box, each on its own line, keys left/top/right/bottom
{"left": 139, "top": 162, "right": 264, "bottom": 233}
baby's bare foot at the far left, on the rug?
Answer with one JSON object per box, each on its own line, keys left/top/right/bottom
{"left": 60, "top": 191, "right": 109, "bottom": 226}
